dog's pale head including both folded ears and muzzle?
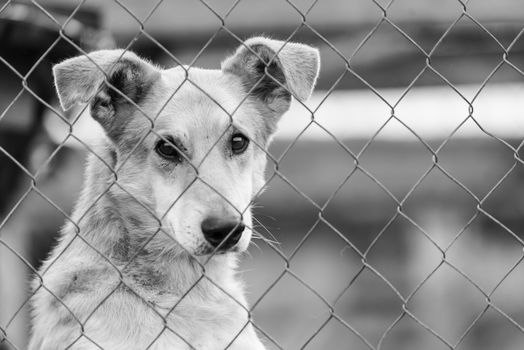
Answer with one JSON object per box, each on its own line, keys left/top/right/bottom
{"left": 53, "top": 37, "right": 319, "bottom": 255}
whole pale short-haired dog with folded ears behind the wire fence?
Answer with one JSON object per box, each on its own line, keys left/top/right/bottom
{"left": 29, "top": 37, "right": 320, "bottom": 350}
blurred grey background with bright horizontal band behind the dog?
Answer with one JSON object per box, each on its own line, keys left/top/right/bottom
{"left": 0, "top": 0, "right": 524, "bottom": 350}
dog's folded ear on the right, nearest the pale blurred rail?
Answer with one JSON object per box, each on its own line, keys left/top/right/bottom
{"left": 222, "top": 37, "right": 320, "bottom": 135}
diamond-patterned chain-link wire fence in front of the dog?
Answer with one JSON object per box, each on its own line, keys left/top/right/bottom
{"left": 0, "top": 0, "right": 524, "bottom": 350}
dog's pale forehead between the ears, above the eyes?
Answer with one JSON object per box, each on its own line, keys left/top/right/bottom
{"left": 150, "top": 67, "right": 254, "bottom": 136}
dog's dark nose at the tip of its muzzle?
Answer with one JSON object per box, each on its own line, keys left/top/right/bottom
{"left": 202, "top": 217, "right": 246, "bottom": 250}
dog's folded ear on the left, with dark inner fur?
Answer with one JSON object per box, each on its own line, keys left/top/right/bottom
{"left": 53, "top": 50, "right": 160, "bottom": 142}
